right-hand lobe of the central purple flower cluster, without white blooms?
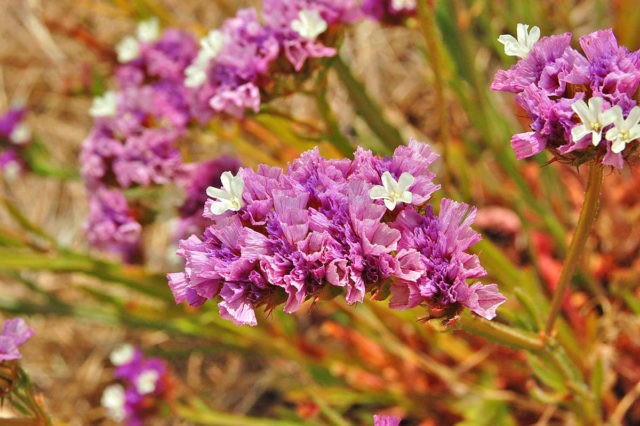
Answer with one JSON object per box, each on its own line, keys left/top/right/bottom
{"left": 389, "top": 198, "right": 506, "bottom": 319}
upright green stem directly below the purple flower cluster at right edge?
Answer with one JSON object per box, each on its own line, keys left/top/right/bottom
{"left": 545, "top": 163, "right": 603, "bottom": 336}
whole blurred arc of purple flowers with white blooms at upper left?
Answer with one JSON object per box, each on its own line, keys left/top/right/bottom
{"left": 82, "top": 0, "right": 424, "bottom": 260}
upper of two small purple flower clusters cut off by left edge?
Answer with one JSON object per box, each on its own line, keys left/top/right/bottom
{"left": 0, "top": 107, "right": 31, "bottom": 179}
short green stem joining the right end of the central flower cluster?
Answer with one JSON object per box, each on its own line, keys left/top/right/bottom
{"left": 458, "top": 313, "right": 544, "bottom": 352}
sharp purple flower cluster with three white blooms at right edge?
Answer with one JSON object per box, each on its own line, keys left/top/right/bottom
{"left": 491, "top": 24, "right": 640, "bottom": 168}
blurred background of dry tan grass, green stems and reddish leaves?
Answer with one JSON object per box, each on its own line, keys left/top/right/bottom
{"left": 0, "top": 0, "right": 640, "bottom": 426}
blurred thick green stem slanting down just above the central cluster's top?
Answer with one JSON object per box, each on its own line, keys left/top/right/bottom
{"left": 331, "top": 56, "right": 404, "bottom": 154}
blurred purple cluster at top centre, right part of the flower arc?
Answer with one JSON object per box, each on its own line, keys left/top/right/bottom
{"left": 185, "top": 0, "right": 359, "bottom": 117}
